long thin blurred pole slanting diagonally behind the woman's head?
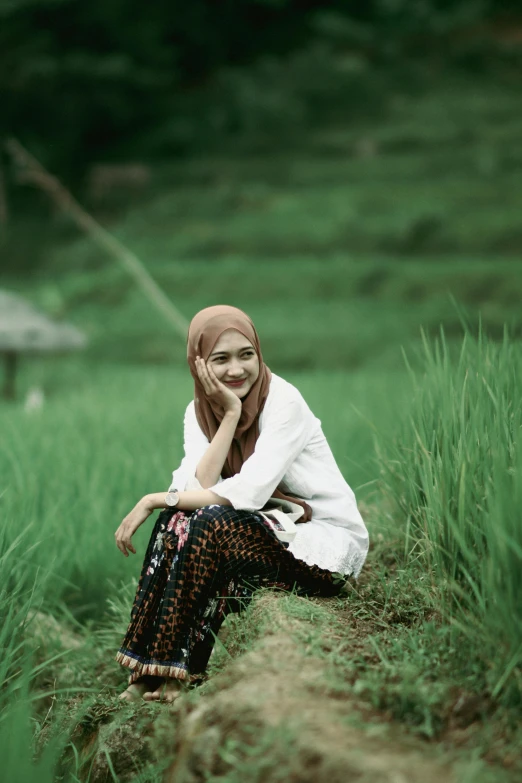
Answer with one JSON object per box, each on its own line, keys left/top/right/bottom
{"left": 5, "top": 139, "right": 188, "bottom": 340}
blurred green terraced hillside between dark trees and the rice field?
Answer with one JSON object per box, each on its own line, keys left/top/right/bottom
{"left": 5, "top": 78, "right": 522, "bottom": 371}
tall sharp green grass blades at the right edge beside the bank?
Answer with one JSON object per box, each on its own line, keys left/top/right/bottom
{"left": 381, "top": 334, "right": 522, "bottom": 707}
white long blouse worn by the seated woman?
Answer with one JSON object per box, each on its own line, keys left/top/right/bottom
{"left": 170, "top": 373, "right": 368, "bottom": 577}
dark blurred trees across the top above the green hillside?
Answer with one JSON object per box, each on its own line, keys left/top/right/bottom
{"left": 0, "top": 0, "right": 520, "bottom": 174}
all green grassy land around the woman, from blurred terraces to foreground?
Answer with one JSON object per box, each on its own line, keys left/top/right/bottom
{"left": 0, "top": 84, "right": 522, "bottom": 783}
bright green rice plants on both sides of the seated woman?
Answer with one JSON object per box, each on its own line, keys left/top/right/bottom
{"left": 0, "top": 324, "right": 522, "bottom": 783}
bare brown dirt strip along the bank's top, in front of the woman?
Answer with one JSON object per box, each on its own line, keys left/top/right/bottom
{"left": 165, "top": 596, "right": 454, "bottom": 783}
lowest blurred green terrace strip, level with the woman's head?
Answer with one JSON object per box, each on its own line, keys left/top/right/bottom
{"left": 6, "top": 258, "right": 522, "bottom": 372}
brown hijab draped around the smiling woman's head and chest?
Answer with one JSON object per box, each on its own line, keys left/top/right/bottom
{"left": 187, "top": 305, "right": 312, "bottom": 522}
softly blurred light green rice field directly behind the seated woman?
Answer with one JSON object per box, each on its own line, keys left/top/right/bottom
{"left": 0, "top": 363, "right": 401, "bottom": 615}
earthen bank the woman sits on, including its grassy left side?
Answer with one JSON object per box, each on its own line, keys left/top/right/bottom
{"left": 71, "top": 592, "right": 515, "bottom": 783}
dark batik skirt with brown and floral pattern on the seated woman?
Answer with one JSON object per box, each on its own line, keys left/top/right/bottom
{"left": 116, "top": 505, "right": 342, "bottom": 683}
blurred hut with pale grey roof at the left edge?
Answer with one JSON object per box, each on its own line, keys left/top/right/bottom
{"left": 0, "top": 290, "right": 87, "bottom": 405}
